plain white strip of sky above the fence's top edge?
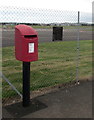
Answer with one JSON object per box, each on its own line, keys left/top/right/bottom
{"left": 0, "top": 0, "right": 94, "bottom": 12}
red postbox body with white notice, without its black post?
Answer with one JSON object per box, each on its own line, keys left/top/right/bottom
{"left": 15, "top": 25, "right": 38, "bottom": 62}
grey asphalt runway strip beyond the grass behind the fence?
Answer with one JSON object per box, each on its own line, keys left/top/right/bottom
{"left": 2, "top": 29, "right": 92, "bottom": 47}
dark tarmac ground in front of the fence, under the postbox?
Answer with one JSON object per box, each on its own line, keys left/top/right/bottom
{"left": 3, "top": 81, "right": 92, "bottom": 118}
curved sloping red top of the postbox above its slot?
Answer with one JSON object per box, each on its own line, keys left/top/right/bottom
{"left": 15, "top": 25, "right": 37, "bottom": 35}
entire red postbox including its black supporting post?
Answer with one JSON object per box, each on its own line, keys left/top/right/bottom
{"left": 15, "top": 25, "right": 38, "bottom": 107}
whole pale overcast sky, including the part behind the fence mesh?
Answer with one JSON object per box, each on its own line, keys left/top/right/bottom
{"left": 0, "top": 0, "right": 93, "bottom": 23}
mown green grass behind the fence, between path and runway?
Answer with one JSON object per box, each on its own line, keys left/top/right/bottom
{"left": 3, "top": 40, "right": 92, "bottom": 98}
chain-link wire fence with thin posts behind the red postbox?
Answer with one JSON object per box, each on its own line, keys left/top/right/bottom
{"left": 0, "top": 7, "right": 92, "bottom": 105}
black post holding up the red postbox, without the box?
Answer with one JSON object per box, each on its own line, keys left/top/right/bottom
{"left": 23, "top": 62, "right": 30, "bottom": 107}
